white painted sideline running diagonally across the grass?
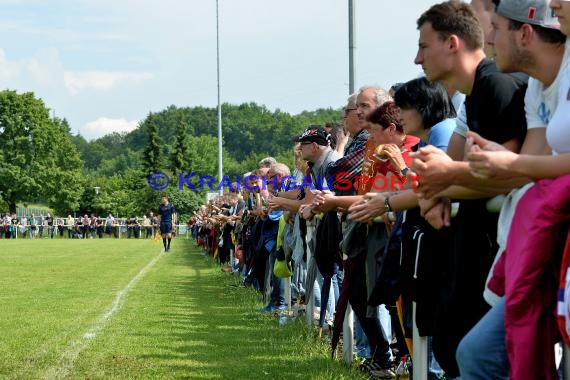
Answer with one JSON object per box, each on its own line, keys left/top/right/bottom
{"left": 43, "top": 251, "right": 163, "bottom": 379}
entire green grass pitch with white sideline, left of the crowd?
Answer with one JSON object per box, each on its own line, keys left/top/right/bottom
{"left": 0, "top": 239, "right": 364, "bottom": 380}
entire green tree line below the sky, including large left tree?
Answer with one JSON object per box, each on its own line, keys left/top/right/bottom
{"left": 0, "top": 90, "right": 342, "bottom": 221}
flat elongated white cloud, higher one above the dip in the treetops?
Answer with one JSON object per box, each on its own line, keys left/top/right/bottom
{"left": 63, "top": 71, "right": 153, "bottom": 95}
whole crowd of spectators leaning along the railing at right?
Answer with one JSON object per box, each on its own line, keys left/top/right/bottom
{"left": 189, "top": 0, "right": 570, "bottom": 380}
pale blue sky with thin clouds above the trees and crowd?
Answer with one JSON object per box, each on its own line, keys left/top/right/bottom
{"left": 0, "top": 0, "right": 428, "bottom": 139}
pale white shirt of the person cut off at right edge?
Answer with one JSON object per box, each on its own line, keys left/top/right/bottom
{"left": 546, "top": 66, "right": 570, "bottom": 155}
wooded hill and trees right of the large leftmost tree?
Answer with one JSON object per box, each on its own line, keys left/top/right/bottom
{"left": 66, "top": 103, "right": 341, "bottom": 216}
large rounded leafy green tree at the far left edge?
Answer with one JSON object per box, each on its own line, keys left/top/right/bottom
{"left": 0, "top": 90, "right": 83, "bottom": 212}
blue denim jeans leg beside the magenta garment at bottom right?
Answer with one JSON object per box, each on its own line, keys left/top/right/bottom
{"left": 456, "top": 298, "right": 509, "bottom": 380}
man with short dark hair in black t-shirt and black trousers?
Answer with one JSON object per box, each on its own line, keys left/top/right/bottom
{"left": 406, "top": 0, "right": 526, "bottom": 378}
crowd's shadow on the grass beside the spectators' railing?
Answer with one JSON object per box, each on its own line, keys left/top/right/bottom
{"left": 134, "top": 243, "right": 362, "bottom": 379}
